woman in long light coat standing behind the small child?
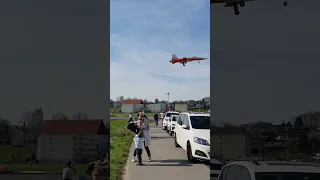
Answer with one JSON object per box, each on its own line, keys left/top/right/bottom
{"left": 132, "top": 114, "right": 151, "bottom": 162}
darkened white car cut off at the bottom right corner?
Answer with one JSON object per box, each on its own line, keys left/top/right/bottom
{"left": 218, "top": 160, "right": 320, "bottom": 180}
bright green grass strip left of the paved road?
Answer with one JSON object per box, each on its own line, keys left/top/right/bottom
{"left": 110, "top": 120, "right": 134, "bottom": 180}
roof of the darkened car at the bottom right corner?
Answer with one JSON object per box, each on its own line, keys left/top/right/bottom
{"left": 225, "top": 161, "right": 320, "bottom": 173}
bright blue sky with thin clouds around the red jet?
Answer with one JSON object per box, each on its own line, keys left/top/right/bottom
{"left": 110, "top": 0, "right": 210, "bottom": 100}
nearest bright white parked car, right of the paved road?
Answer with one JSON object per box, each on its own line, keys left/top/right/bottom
{"left": 173, "top": 112, "right": 210, "bottom": 162}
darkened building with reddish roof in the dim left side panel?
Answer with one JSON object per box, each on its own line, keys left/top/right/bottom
{"left": 37, "top": 120, "right": 109, "bottom": 163}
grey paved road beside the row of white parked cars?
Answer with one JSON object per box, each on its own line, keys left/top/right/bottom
{"left": 124, "top": 126, "right": 210, "bottom": 180}
